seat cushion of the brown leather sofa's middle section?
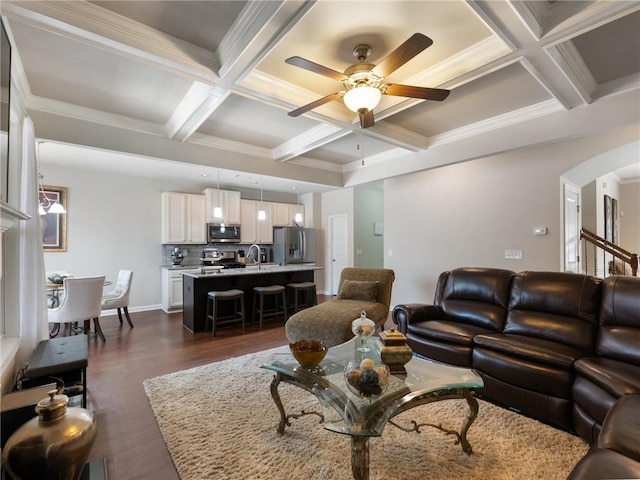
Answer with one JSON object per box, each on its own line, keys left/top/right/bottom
{"left": 474, "top": 333, "right": 584, "bottom": 370}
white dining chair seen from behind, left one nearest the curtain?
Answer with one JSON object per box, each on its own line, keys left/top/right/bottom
{"left": 47, "top": 275, "right": 106, "bottom": 342}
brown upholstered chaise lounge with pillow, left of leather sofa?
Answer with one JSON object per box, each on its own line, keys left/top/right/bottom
{"left": 285, "top": 268, "right": 395, "bottom": 347}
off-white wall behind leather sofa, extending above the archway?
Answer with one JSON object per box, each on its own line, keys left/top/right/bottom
{"left": 384, "top": 128, "right": 638, "bottom": 304}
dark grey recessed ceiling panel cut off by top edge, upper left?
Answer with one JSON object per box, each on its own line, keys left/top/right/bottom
{"left": 91, "top": 0, "right": 247, "bottom": 52}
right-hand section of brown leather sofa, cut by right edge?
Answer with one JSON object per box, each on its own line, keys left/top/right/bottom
{"left": 572, "top": 276, "right": 640, "bottom": 443}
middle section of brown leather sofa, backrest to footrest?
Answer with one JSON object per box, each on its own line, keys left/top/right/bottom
{"left": 473, "top": 272, "right": 601, "bottom": 430}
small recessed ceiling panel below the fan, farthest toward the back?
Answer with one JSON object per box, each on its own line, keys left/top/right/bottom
{"left": 305, "top": 133, "right": 395, "bottom": 165}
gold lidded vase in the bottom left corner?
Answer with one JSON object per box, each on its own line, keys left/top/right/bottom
{"left": 2, "top": 390, "right": 98, "bottom": 480}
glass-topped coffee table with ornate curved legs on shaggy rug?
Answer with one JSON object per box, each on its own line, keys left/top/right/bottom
{"left": 261, "top": 337, "right": 483, "bottom": 480}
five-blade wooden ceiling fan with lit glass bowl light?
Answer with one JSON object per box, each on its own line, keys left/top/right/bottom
{"left": 285, "top": 33, "right": 449, "bottom": 128}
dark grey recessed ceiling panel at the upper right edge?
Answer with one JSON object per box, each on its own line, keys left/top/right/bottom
{"left": 573, "top": 12, "right": 640, "bottom": 84}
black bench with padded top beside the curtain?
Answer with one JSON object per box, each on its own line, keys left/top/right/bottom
{"left": 22, "top": 335, "right": 89, "bottom": 408}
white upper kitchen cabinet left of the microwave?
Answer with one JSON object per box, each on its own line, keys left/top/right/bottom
{"left": 161, "top": 192, "right": 207, "bottom": 244}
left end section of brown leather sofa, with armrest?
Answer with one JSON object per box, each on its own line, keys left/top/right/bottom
{"left": 392, "top": 268, "right": 515, "bottom": 367}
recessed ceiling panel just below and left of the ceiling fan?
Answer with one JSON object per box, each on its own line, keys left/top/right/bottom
{"left": 198, "top": 95, "right": 318, "bottom": 148}
